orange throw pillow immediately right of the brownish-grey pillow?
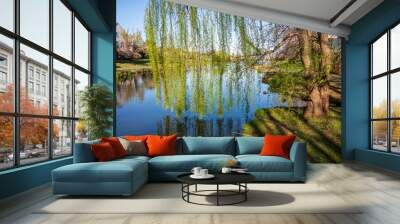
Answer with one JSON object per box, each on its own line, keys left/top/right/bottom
{"left": 146, "top": 135, "right": 177, "bottom": 157}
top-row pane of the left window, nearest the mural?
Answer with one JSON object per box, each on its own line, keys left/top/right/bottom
{"left": 75, "top": 18, "right": 89, "bottom": 70}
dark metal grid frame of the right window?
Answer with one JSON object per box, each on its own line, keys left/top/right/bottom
{"left": 368, "top": 21, "right": 400, "bottom": 155}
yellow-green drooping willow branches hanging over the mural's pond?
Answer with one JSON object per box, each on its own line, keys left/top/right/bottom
{"left": 145, "top": 0, "right": 268, "bottom": 117}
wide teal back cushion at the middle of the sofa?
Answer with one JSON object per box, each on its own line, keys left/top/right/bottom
{"left": 182, "top": 137, "right": 235, "bottom": 155}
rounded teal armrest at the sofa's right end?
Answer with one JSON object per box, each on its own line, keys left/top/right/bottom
{"left": 290, "top": 142, "right": 307, "bottom": 181}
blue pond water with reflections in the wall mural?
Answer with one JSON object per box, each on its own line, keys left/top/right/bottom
{"left": 117, "top": 63, "right": 284, "bottom": 136}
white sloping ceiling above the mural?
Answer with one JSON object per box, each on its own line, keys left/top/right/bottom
{"left": 169, "top": 0, "right": 383, "bottom": 37}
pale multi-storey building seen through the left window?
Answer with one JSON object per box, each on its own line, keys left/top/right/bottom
{"left": 0, "top": 42, "right": 79, "bottom": 148}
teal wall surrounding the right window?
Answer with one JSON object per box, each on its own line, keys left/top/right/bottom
{"left": 342, "top": 0, "right": 400, "bottom": 170}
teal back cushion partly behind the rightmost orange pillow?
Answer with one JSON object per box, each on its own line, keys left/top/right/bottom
{"left": 236, "top": 137, "right": 264, "bottom": 155}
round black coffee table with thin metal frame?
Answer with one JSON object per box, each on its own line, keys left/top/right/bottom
{"left": 177, "top": 173, "right": 255, "bottom": 206}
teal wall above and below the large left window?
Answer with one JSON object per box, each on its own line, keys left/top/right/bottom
{"left": 0, "top": 0, "right": 116, "bottom": 199}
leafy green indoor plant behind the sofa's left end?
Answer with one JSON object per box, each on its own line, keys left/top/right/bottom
{"left": 79, "top": 85, "right": 113, "bottom": 139}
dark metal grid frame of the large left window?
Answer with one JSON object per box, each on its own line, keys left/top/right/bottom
{"left": 0, "top": 0, "right": 93, "bottom": 172}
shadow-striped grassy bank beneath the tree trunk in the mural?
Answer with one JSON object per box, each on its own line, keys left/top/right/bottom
{"left": 243, "top": 108, "right": 341, "bottom": 163}
